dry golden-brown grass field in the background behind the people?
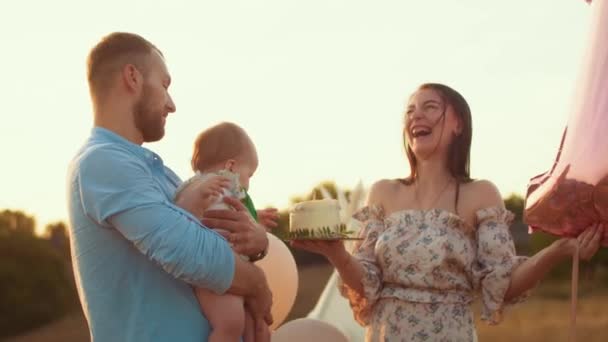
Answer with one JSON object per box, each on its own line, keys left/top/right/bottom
{"left": 9, "top": 266, "right": 608, "bottom": 342}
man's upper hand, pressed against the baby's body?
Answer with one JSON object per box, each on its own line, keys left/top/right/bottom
{"left": 202, "top": 197, "right": 268, "bottom": 256}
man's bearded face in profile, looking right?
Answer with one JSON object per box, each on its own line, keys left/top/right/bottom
{"left": 133, "top": 51, "right": 175, "bottom": 142}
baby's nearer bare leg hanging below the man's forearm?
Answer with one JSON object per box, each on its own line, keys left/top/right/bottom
{"left": 200, "top": 288, "right": 245, "bottom": 342}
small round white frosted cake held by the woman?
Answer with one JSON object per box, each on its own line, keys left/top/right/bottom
{"left": 289, "top": 199, "right": 340, "bottom": 234}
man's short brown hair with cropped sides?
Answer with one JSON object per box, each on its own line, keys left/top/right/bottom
{"left": 87, "top": 32, "right": 162, "bottom": 99}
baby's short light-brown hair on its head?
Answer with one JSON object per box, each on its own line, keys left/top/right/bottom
{"left": 191, "top": 122, "right": 251, "bottom": 172}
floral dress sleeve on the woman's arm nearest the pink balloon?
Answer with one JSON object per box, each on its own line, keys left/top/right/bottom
{"left": 473, "top": 207, "right": 529, "bottom": 324}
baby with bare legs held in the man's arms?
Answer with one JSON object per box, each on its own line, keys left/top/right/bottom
{"left": 175, "top": 122, "right": 276, "bottom": 342}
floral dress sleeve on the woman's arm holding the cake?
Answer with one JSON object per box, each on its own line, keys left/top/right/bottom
{"left": 338, "top": 205, "right": 384, "bottom": 326}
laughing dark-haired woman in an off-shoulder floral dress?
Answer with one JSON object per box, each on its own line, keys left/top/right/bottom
{"left": 293, "top": 84, "right": 603, "bottom": 342}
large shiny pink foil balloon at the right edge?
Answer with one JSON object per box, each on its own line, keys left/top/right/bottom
{"left": 524, "top": 0, "right": 608, "bottom": 246}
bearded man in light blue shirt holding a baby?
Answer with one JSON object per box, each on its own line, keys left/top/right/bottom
{"left": 67, "top": 33, "right": 272, "bottom": 342}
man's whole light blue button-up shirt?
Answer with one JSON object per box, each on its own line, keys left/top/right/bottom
{"left": 67, "top": 127, "right": 234, "bottom": 342}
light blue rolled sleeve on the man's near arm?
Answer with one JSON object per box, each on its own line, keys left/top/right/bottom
{"left": 78, "top": 146, "right": 235, "bottom": 293}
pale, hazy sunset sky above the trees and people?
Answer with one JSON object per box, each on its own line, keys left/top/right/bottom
{"left": 0, "top": 0, "right": 591, "bottom": 234}
